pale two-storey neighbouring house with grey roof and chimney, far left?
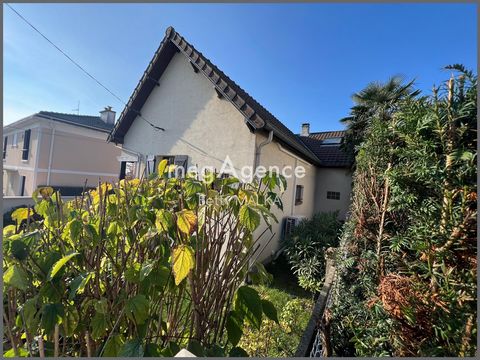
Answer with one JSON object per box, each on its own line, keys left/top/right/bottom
{"left": 3, "top": 108, "right": 121, "bottom": 196}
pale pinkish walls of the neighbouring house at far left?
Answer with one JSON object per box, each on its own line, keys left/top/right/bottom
{"left": 3, "top": 116, "right": 121, "bottom": 196}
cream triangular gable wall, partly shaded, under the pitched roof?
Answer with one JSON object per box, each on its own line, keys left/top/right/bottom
{"left": 123, "top": 54, "right": 255, "bottom": 175}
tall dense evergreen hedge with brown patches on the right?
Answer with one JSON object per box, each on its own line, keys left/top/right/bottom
{"left": 332, "top": 65, "right": 477, "bottom": 356}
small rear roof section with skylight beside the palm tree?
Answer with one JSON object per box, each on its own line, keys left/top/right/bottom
{"left": 299, "top": 130, "right": 353, "bottom": 167}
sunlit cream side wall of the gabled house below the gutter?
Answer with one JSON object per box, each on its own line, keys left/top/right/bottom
{"left": 254, "top": 134, "right": 316, "bottom": 261}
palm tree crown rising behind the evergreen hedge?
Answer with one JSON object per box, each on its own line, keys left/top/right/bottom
{"left": 340, "top": 76, "right": 420, "bottom": 156}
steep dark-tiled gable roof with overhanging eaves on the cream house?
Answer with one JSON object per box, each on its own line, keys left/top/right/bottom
{"left": 108, "top": 27, "right": 319, "bottom": 164}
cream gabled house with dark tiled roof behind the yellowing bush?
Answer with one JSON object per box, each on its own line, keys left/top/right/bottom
{"left": 109, "top": 27, "right": 351, "bottom": 259}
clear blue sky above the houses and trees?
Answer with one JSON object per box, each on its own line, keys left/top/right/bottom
{"left": 3, "top": 4, "right": 477, "bottom": 132}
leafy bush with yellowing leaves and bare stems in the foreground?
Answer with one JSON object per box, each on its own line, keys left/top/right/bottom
{"left": 3, "top": 165, "right": 285, "bottom": 356}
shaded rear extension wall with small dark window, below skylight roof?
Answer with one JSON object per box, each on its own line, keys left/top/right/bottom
{"left": 315, "top": 168, "right": 352, "bottom": 220}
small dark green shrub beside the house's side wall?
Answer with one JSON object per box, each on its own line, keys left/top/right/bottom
{"left": 286, "top": 212, "right": 341, "bottom": 292}
